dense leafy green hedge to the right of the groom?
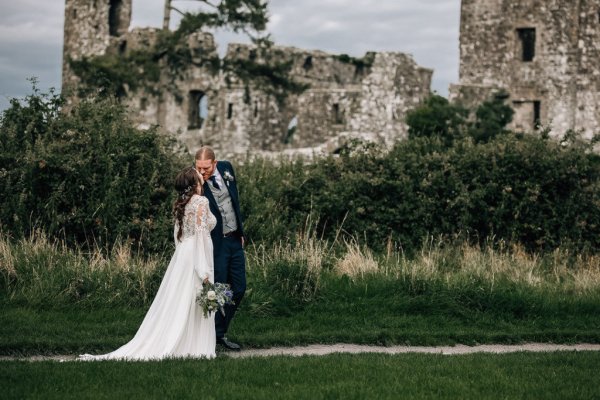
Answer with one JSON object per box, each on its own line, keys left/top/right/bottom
{"left": 238, "top": 133, "right": 600, "bottom": 251}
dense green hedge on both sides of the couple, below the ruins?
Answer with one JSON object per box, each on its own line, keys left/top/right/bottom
{"left": 0, "top": 86, "right": 600, "bottom": 253}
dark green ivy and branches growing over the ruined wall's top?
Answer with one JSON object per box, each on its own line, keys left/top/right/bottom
{"left": 69, "top": 0, "right": 308, "bottom": 104}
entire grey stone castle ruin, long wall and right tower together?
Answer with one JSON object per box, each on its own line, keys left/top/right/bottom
{"left": 63, "top": 0, "right": 600, "bottom": 154}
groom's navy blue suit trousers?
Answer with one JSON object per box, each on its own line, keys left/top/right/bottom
{"left": 215, "top": 236, "right": 246, "bottom": 339}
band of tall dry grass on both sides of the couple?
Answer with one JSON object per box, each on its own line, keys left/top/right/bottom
{"left": 0, "top": 229, "right": 600, "bottom": 307}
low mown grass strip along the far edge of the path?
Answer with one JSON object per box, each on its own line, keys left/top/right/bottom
{"left": 0, "top": 296, "right": 600, "bottom": 355}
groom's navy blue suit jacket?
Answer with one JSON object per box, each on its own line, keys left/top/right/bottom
{"left": 203, "top": 161, "right": 244, "bottom": 252}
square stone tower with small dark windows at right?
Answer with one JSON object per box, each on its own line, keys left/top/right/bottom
{"left": 450, "top": 0, "right": 600, "bottom": 137}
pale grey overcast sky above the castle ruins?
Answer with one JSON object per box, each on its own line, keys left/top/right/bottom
{"left": 0, "top": 0, "right": 460, "bottom": 110}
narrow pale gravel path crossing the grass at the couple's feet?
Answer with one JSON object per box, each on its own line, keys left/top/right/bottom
{"left": 0, "top": 343, "right": 600, "bottom": 361}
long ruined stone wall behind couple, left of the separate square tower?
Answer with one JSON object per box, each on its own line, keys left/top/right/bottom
{"left": 63, "top": 0, "right": 433, "bottom": 154}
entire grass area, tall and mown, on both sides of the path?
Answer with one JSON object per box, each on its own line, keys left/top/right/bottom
{"left": 0, "top": 230, "right": 600, "bottom": 399}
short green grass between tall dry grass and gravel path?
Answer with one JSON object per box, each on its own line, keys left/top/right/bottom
{"left": 0, "top": 278, "right": 600, "bottom": 354}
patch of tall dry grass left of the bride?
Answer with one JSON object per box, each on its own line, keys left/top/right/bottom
{"left": 0, "top": 232, "right": 166, "bottom": 306}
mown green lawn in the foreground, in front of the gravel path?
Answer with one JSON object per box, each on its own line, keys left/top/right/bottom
{"left": 0, "top": 352, "right": 600, "bottom": 400}
